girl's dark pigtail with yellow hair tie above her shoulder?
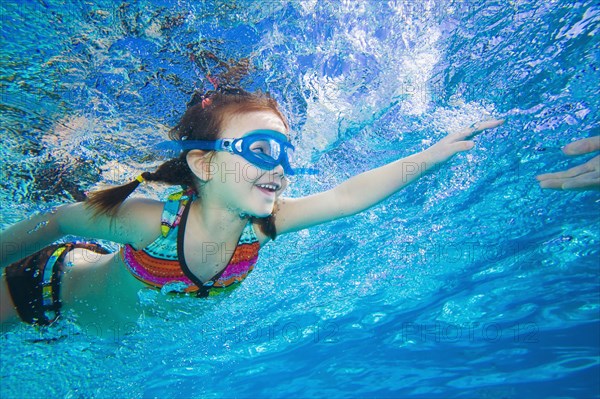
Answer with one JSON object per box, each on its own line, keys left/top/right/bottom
{"left": 85, "top": 153, "right": 194, "bottom": 216}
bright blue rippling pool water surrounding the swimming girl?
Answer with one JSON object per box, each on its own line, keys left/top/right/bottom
{"left": 0, "top": 0, "right": 600, "bottom": 398}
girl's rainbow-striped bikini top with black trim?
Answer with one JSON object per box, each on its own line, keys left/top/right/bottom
{"left": 121, "top": 191, "right": 260, "bottom": 297}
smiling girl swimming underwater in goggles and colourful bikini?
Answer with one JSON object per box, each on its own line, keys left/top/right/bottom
{"left": 0, "top": 90, "right": 503, "bottom": 334}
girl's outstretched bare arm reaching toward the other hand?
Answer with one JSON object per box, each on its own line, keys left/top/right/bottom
{"left": 275, "top": 120, "right": 504, "bottom": 238}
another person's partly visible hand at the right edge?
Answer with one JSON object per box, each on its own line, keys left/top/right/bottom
{"left": 536, "top": 136, "right": 600, "bottom": 190}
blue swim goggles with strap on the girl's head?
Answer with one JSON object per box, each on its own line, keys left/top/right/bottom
{"left": 159, "top": 129, "right": 295, "bottom": 175}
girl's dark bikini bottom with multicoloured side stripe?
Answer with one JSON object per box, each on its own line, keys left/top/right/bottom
{"left": 4, "top": 243, "right": 110, "bottom": 326}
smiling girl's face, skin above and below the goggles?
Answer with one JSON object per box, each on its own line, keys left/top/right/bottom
{"left": 210, "top": 111, "right": 287, "bottom": 217}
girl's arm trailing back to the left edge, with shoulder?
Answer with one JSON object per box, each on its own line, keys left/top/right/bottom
{"left": 0, "top": 198, "right": 163, "bottom": 268}
